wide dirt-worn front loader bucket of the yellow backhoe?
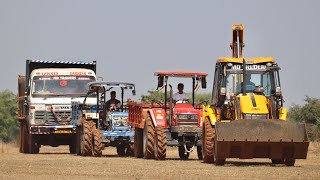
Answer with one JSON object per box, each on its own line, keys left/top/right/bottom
{"left": 215, "top": 119, "right": 309, "bottom": 160}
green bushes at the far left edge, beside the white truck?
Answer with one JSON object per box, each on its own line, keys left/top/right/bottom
{"left": 0, "top": 90, "right": 19, "bottom": 142}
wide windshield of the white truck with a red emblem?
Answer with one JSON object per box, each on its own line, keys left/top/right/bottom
{"left": 32, "top": 76, "right": 95, "bottom": 97}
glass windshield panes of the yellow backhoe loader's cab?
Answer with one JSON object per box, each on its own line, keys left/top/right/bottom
{"left": 226, "top": 71, "right": 275, "bottom": 96}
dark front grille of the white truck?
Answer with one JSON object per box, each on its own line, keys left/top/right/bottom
{"left": 35, "top": 111, "right": 71, "bottom": 125}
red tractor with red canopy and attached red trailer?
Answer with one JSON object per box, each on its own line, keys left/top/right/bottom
{"left": 129, "top": 71, "right": 208, "bottom": 160}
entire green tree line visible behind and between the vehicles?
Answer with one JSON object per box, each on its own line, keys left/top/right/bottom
{"left": 0, "top": 90, "right": 320, "bottom": 142}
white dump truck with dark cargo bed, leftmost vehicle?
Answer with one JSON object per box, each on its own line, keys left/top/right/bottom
{"left": 18, "top": 60, "right": 96, "bottom": 154}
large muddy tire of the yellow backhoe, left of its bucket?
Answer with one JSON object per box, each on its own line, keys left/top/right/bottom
{"left": 202, "top": 119, "right": 215, "bottom": 164}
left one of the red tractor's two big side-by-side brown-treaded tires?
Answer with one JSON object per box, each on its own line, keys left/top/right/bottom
{"left": 144, "top": 118, "right": 155, "bottom": 159}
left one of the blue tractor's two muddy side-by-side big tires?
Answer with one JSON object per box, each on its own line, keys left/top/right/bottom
{"left": 80, "top": 121, "right": 92, "bottom": 156}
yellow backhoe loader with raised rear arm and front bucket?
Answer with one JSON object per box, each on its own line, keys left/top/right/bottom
{"left": 203, "top": 25, "right": 309, "bottom": 166}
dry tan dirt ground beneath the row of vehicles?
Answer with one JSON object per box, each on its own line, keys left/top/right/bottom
{"left": 0, "top": 142, "right": 320, "bottom": 179}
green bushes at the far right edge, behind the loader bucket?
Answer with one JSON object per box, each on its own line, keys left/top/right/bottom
{"left": 288, "top": 96, "right": 320, "bottom": 141}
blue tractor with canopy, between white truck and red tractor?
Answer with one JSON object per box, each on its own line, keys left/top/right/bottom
{"left": 72, "top": 81, "right": 135, "bottom": 157}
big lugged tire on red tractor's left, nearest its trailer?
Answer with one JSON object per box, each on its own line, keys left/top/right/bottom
{"left": 143, "top": 117, "right": 155, "bottom": 159}
